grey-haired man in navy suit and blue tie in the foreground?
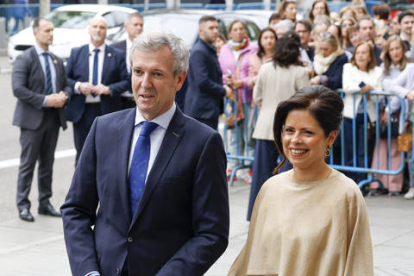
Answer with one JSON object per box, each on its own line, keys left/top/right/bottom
{"left": 61, "top": 33, "right": 229, "bottom": 276}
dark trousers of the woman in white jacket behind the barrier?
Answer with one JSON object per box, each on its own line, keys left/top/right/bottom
{"left": 344, "top": 113, "right": 373, "bottom": 183}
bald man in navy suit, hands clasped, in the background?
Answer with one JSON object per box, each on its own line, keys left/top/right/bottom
{"left": 66, "top": 16, "right": 130, "bottom": 162}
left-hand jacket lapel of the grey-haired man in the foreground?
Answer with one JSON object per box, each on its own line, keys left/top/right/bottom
{"left": 116, "top": 108, "right": 136, "bottom": 222}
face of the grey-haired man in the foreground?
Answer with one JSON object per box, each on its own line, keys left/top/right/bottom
{"left": 131, "top": 46, "right": 187, "bottom": 120}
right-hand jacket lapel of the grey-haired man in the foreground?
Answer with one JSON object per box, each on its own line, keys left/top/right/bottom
{"left": 130, "top": 108, "right": 184, "bottom": 229}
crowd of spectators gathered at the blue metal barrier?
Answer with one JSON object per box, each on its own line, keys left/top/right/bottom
{"left": 212, "top": 0, "right": 414, "bottom": 203}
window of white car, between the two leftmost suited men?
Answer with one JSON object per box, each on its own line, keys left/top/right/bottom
{"left": 46, "top": 11, "right": 96, "bottom": 29}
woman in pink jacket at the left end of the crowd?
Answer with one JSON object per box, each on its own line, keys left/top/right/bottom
{"left": 219, "top": 20, "right": 258, "bottom": 183}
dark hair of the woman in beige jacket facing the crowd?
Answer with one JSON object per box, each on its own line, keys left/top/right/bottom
{"left": 273, "top": 31, "right": 301, "bottom": 67}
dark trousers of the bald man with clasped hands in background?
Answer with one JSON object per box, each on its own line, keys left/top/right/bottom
{"left": 73, "top": 103, "right": 101, "bottom": 164}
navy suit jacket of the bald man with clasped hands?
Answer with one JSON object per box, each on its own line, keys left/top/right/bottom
{"left": 66, "top": 44, "right": 130, "bottom": 123}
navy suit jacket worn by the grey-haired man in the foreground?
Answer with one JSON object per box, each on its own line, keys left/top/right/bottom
{"left": 61, "top": 108, "right": 229, "bottom": 276}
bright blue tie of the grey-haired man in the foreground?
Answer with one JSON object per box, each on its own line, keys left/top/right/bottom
{"left": 129, "top": 122, "right": 158, "bottom": 217}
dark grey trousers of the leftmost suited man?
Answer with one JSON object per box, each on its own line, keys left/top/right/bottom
{"left": 16, "top": 109, "right": 60, "bottom": 211}
